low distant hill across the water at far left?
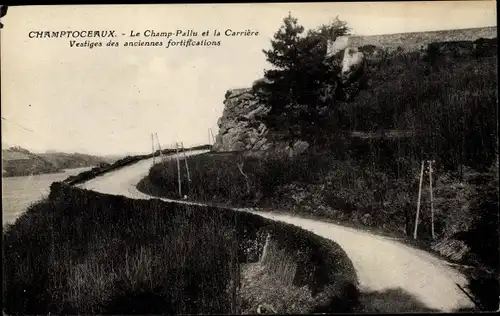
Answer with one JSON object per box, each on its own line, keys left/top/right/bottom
{"left": 2, "top": 147, "right": 115, "bottom": 177}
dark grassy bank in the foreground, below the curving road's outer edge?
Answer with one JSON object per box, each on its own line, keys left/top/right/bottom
{"left": 3, "top": 183, "right": 358, "bottom": 314}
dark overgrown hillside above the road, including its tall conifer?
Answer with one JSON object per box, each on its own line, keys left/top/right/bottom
{"left": 138, "top": 16, "right": 499, "bottom": 310}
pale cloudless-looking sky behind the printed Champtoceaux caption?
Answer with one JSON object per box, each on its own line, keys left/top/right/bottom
{"left": 1, "top": 1, "right": 496, "bottom": 154}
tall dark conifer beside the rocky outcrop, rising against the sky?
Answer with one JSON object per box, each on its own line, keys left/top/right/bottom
{"left": 254, "top": 13, "right": 349, "bottom": 145}
